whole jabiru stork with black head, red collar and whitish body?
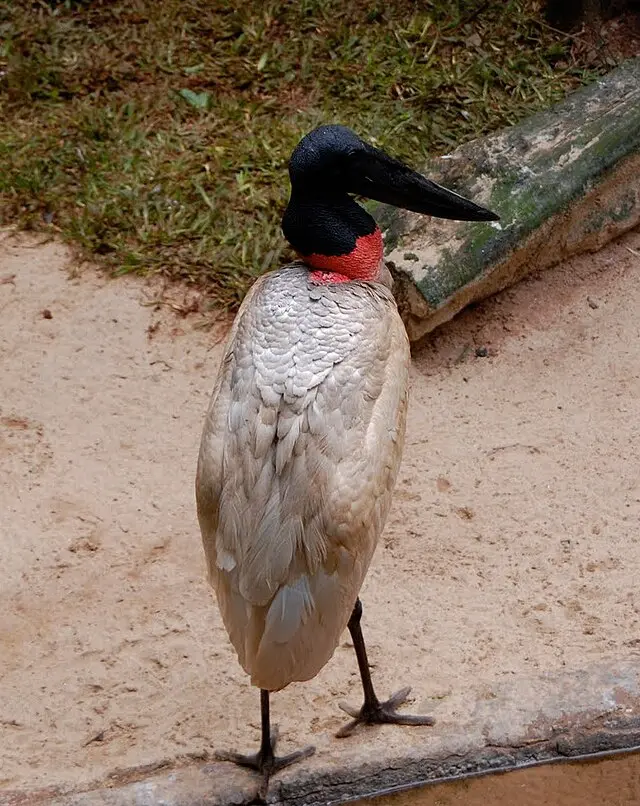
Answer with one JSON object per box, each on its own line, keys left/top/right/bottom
{"left": 196, "top": 124, "right": 498, "bottom": 782}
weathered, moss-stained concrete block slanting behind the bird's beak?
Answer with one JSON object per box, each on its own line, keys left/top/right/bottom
{"left": 374, "top": 58, "right": 640, "bottom": 340}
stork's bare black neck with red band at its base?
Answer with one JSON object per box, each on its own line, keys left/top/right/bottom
{"left": 282, "top": 190, "right": 383, "bottom": 283}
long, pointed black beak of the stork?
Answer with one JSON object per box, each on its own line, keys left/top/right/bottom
{"left": 344, "top": 144, "right": 500, "bottom": 221}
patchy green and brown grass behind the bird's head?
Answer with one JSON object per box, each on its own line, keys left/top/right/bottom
{"left": 0, "top": 0, "right": 611, "bottom": 308}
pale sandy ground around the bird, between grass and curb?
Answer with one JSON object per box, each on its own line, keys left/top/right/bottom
{"left": 0, "top": 232, "right": 640, "bottom": 789}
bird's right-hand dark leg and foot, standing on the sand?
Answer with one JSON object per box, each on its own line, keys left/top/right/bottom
{"left": 336, "top": 599, "right": 434, "bottom": 738}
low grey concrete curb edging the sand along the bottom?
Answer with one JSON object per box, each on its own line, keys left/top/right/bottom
{"left": 7, "top": 662, "right": 640, "bottom": 806}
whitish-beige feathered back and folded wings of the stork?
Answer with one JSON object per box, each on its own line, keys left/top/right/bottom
{"left": 196, "top": 264, "right": 409, "bottom": 691}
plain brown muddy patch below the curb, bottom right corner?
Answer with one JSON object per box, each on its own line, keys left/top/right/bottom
{"left": 357, "top": 753, "right": 640, "bottom": 806}
